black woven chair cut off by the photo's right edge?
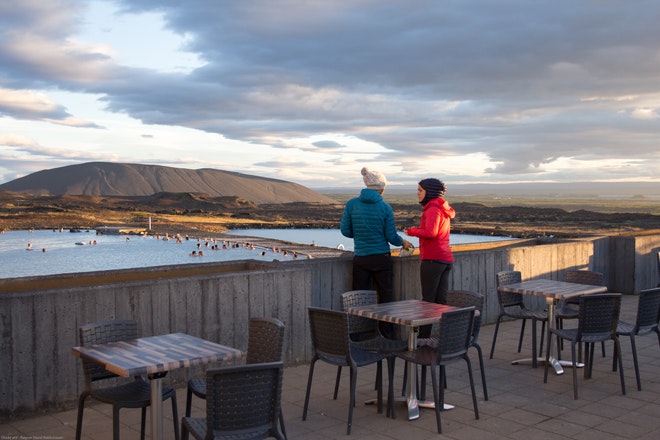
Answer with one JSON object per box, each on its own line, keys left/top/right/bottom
{"left": 612, "top": 287, "right": 660, "bottom": 391}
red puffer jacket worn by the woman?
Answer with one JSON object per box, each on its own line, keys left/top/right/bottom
{"left": 406, "top": 198, "right": 456, "bottom": 263}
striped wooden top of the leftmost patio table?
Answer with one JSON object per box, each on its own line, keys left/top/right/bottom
{"left": 71, "top": 333, "right": 243, "bottom": 377}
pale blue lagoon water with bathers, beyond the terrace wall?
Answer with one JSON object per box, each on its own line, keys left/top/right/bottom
{"left": 0, "top": 229, "right": 504, "bottom": 278}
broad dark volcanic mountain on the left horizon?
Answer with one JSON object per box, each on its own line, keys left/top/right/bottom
{"left": 0, "top": 162, "right": 335, "bottom": 204}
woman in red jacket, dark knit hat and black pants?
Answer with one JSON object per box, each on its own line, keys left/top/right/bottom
{"left": 406, "top": 178, "right": 456, "bottom": 338}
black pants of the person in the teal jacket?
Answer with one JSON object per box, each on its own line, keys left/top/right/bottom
{"left": 353, "top": 253, "right": 396, "bottom": 338}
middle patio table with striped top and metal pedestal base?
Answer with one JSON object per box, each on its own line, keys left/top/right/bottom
{"left": 346, "top": 299, "right": 456, "bottom": 420}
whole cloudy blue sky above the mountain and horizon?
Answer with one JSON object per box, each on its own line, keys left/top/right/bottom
{"left": 0, "top": 0, "right": 660, "bottom": 188}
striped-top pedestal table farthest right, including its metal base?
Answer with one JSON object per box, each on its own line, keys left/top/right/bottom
{"left": 498, "top": 278, "right": 607, "bottom": 374}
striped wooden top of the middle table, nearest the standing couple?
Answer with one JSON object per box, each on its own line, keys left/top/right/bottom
{"left": 346, "top": 299, "right": 456, "bottom": 327}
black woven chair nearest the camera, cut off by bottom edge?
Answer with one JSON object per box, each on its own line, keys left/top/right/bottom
{"left": 181, "top": 362, "right": 285, "bottom": 440}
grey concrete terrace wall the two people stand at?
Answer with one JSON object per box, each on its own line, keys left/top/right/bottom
{"left": 0, "top": 235, "right": 660, "bottom": 421}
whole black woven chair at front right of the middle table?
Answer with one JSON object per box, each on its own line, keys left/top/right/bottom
{"left": 388, "top": 307, "right": 479, "bottom": 433}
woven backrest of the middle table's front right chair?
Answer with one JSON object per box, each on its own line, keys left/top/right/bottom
{"left": 438, "top": 307, "right": 476, "bottom": 362}
